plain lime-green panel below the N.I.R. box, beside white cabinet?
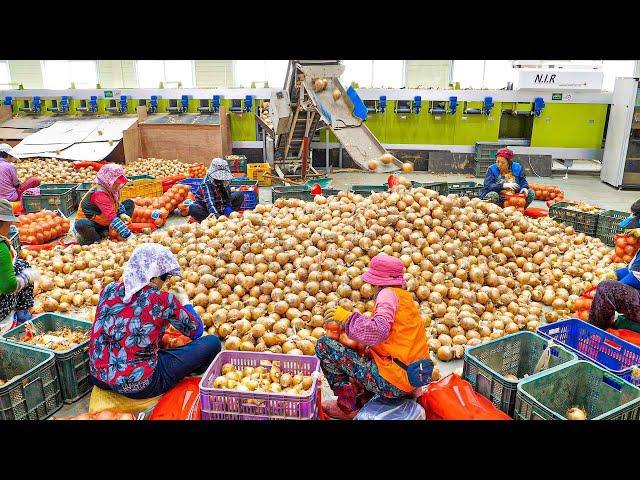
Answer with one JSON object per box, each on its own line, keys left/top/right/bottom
{"left": 531, "top": 103, "right": 607, "bottom": 148}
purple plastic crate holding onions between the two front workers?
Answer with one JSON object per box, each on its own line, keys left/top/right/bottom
{"left": 200, "top": 350, "right": 320, "bottom": 420}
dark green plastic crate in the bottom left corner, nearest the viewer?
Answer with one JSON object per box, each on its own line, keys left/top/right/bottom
{"left": 0, "top": 341, "right": 63, "bottom": 420}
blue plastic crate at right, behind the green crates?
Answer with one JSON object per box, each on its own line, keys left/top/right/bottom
{"left": 538, "top": 318, "right": 640, "bottom": 385}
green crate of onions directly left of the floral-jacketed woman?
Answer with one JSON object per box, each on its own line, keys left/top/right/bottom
{"left": 2, "top": 313, "right": 92, "bottom": 403}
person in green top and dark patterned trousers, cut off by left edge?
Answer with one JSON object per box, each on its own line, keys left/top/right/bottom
{"left": 0, "top": 199, "right": 40, "bottom": 330}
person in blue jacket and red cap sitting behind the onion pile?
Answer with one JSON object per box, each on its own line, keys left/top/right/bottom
{"left": 480, "top": 148, "right": 536, "bottom": 208}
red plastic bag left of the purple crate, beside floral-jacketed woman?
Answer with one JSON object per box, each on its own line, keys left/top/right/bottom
{"left": 149, "top": 377, "right": 201, "bottom": 420}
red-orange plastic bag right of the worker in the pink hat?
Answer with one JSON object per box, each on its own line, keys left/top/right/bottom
{"left": 418, "top": 373, "right": 511, "bottom": 420}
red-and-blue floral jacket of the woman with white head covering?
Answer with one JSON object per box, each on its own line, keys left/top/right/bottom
{"left": 89, "top": 282, "right": 202, "bottom": 390}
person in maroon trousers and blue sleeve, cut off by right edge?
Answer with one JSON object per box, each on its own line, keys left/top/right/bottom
{"left": 588, "top": 200, "right": 640, "bottom": 330}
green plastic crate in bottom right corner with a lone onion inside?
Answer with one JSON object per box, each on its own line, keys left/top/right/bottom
{"left": 514, "top": 361, "right": 640, "bottom": 420}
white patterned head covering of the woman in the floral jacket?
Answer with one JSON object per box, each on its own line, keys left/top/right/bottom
{"left": 123, "top": 246, "right": 180, "bottom": 302}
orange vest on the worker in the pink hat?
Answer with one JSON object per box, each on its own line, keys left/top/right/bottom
{"left": 371, "top": 288, "right": 429, "bottom": 392}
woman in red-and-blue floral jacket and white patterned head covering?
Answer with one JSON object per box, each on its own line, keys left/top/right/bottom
{"left": 89, "top": 243, "right": 221, "bottom": 399}
